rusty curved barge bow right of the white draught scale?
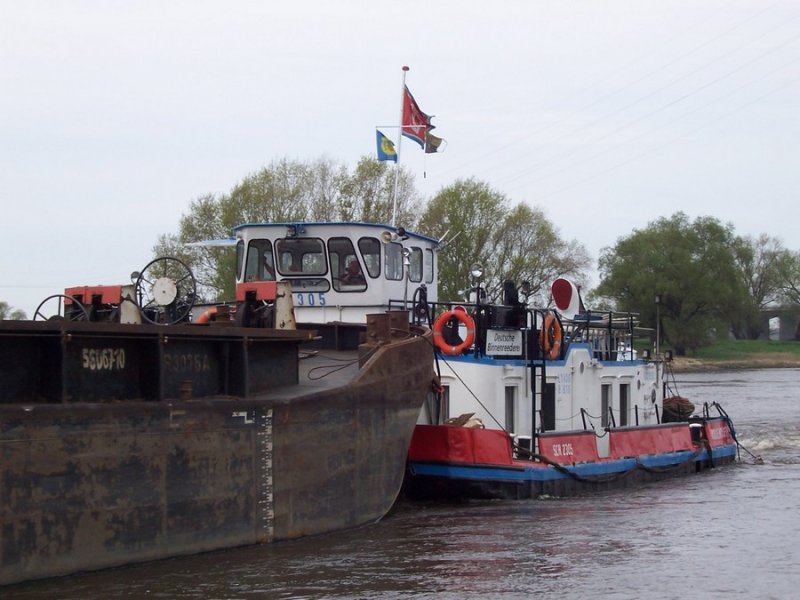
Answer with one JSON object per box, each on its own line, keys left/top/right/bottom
{"left": 274, "top": 326, "right": 433, "bottom": 538}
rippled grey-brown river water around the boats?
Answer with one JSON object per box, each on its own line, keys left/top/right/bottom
{"left": 6, "top": 369, "right": 800, "bottom": 600}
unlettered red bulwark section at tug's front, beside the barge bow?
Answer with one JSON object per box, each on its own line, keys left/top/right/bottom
{"left": 408, "top": 425, "right": 512, "bottom": 465}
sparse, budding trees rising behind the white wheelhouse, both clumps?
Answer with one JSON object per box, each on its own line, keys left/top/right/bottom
{"left": 154, "top": 158, "right": 590, "bottom": 310}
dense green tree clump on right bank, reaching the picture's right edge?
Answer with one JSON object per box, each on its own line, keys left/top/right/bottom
{"left": 592, "top": 212, "right": 800, "bottom": 354}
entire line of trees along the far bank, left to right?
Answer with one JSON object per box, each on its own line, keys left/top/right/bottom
{"left": 0, "top": 157, "right": 800, "bottom": 354}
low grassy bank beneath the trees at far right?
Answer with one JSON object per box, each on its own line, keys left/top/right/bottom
{"left": 673, "top": 340, "right": 800, "bottom": 372}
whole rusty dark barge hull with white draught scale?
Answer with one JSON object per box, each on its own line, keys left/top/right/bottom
{"left": 0, "top": 322, "right": 432, "bottom": 584}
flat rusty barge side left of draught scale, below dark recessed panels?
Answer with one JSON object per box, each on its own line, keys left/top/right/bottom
{"left": 0, "top": 402, "right": 266, "bottom": 583}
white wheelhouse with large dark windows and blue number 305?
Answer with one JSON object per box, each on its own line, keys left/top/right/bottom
{"left": 234, "top": 222, "right": 439, "bottom": 323}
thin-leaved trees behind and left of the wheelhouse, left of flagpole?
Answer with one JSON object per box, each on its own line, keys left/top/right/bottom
{"left": 153, "top": 158, "right": 421, "bottom": 302}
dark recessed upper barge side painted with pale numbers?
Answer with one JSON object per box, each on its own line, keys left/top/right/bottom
{"left": 0, "top": 321, "right": 313, "bottom": 404}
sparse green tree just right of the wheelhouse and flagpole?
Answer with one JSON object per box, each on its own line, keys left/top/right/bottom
{"left": 420, "top": 179, "right": 589, "bottom": 301}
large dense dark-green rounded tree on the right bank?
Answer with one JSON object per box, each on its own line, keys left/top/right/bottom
{"left": 596, "top": 213, "right": 747, "bottom": 355}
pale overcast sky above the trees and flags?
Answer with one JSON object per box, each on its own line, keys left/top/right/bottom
{"left": 0, "top": 0, "right": 800, "bottom": 316}
